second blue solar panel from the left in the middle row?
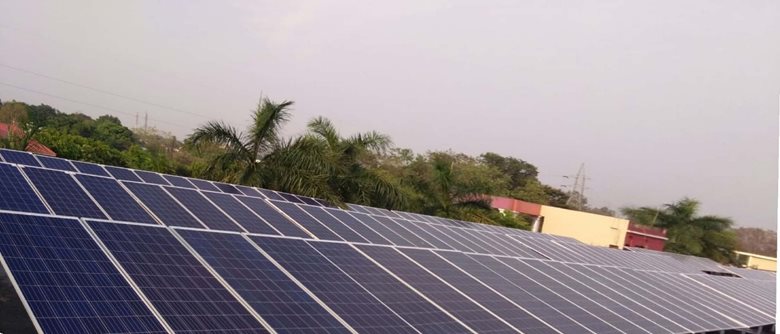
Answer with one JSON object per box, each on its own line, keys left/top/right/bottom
{"left": 24, "top": 167, "right": 107, "bottom": 219}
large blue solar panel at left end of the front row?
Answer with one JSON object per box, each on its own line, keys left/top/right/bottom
{"left": 0, "top": 213, "right": 165, "bottom": 333}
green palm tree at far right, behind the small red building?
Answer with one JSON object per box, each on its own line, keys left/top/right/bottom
{"left": 621, "top": 198, "right": 736, "bottom": 263}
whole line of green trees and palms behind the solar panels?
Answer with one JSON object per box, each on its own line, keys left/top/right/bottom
{"left": 0, "top": 99, "right": 760, "bottom": 262}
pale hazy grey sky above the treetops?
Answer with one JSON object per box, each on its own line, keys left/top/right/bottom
{"left": 0, "top": 0, "right": 780, "bottom": 230}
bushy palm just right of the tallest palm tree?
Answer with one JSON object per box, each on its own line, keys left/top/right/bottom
{"left": 302, "top": 117, "right": 406, "bottom": 209}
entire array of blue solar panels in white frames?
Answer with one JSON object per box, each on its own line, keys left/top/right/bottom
{"left": 0, "top": 150, "right": 776, "bottom": 333}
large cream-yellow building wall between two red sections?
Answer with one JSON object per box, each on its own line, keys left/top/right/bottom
{"left": 539, "top": 205, "right": 628, "bottom": 249}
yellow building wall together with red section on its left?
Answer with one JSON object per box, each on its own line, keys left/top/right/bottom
{"left": 491, "top": 197, "right": 633, "bottom": 249}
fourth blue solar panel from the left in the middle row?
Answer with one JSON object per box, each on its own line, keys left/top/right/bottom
{"left": 123, "top": 182, "right": 203, "bottom": 228}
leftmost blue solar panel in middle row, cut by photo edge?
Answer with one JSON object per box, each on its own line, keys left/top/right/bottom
{"left": 0, "top": 163, "right": 49, "bottom": 213}
